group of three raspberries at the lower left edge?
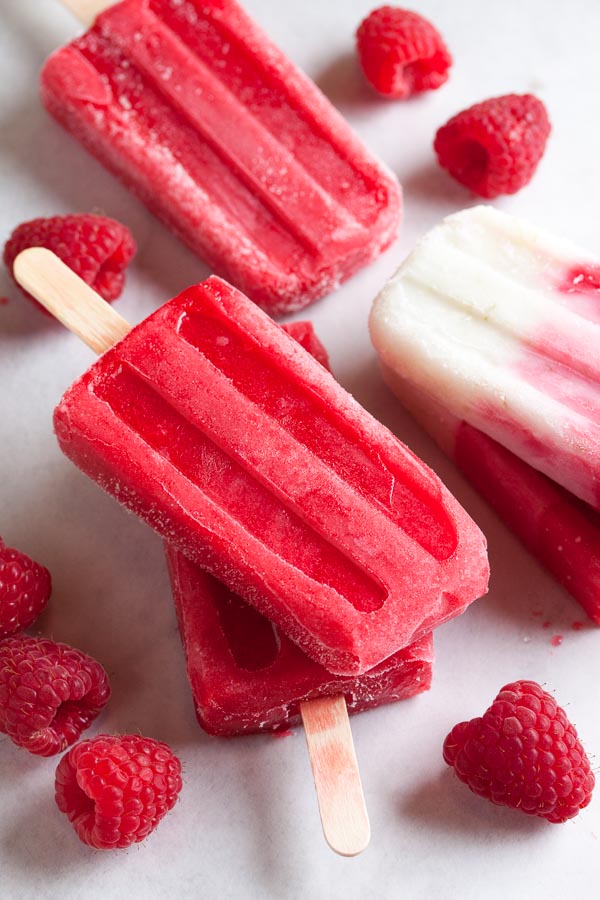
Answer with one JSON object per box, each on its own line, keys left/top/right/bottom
{"left": 0, "top": 539, "right": 181, "bottom": 850}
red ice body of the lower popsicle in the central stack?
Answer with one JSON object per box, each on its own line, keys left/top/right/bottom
{"left": 167, "top": 548, "right": 433, "bottom": 735}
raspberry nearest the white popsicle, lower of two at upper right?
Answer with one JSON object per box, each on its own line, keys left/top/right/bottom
{"left": 433, "top": 94, "right": 550, "bottom": 199}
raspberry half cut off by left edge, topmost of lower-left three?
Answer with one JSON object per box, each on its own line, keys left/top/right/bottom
{"left": 0, "top": 538, "right": 52, "bottom": 640}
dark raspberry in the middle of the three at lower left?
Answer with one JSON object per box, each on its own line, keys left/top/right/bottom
{"left": 0, "top": 637, "right": 110, "bottom": 756}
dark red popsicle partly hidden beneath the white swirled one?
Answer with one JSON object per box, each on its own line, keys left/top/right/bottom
{"left": 383, "top": 367, "right": 600, "bottom": 625}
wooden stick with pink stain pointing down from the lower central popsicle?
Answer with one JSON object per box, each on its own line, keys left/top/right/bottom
{"left": 300, "top": 694, "right": 371, "bottom": 856}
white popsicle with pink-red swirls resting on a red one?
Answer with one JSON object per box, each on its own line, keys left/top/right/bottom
{"left": 370, "top": 207, "right": 600, "bottom": 509}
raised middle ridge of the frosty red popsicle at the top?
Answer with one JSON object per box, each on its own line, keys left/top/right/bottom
{"left": 100, "top": 6, "right": 364, "bottom": 256}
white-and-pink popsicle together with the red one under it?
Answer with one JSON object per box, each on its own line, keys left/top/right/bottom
{"left": 371, "top": 207, "right": 600, "bottom": 624}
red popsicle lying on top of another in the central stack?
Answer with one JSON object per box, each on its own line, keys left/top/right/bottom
{"left": 15, "top": 250, "right": 488, "bottom": 675}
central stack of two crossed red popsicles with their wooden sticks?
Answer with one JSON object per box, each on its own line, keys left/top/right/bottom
{"left": 15, "top": 248, "right": 488, "bottom": 855}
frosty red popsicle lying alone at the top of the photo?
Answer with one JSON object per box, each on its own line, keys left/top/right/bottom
{"left": 41, "top": 0, "right": 401, "bottom": 314}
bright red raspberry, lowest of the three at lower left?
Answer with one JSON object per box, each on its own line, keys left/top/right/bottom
{"left": 56, "top": 734, "right": 181, "bottom": 850}
